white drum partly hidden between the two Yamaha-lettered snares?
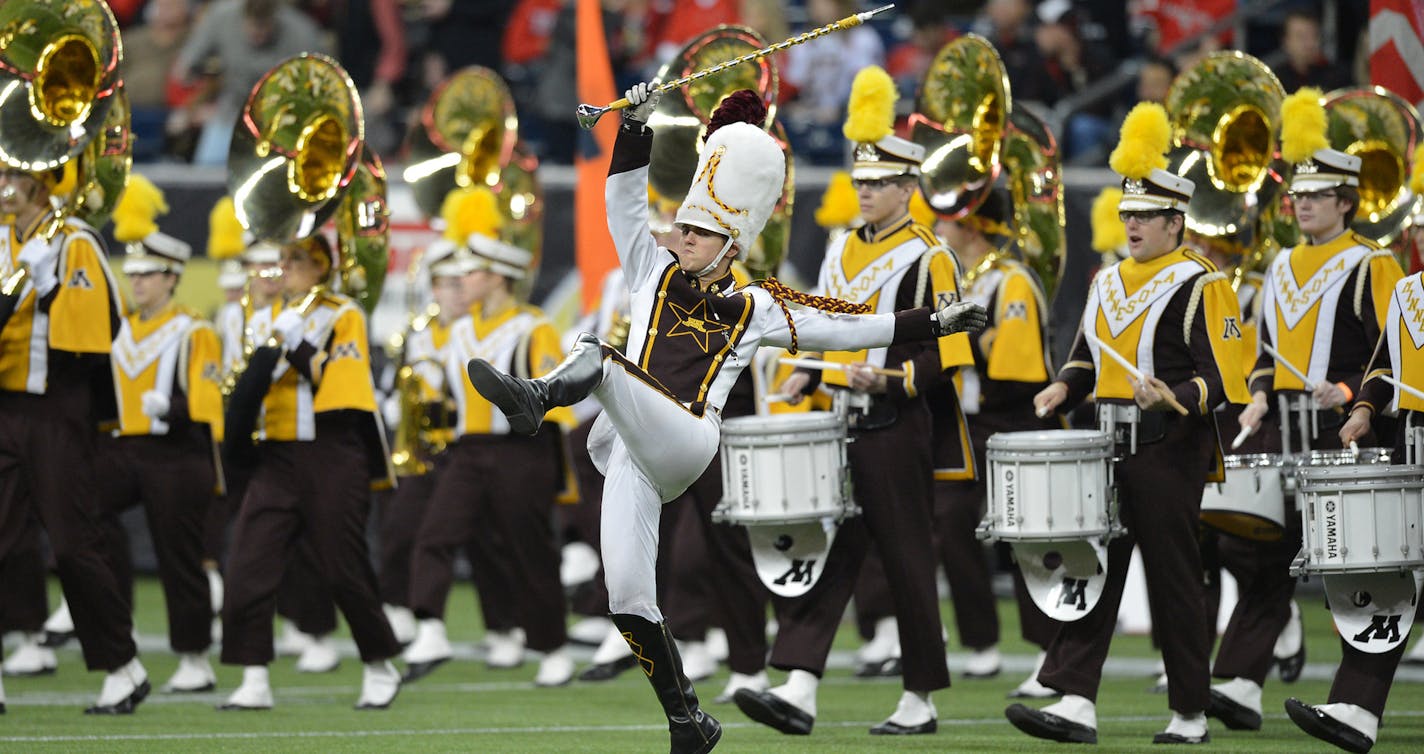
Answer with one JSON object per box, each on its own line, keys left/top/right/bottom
{"left": 1202, "top": 453, "right": 1286, "bottom": 542}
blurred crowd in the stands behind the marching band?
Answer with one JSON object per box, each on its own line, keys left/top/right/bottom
{"left": 122, "top": 0, "right": 1368, "bottom": 165}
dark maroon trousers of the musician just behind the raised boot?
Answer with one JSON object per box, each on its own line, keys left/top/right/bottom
{"left": 410, "top": 432, "right": 568, "bottom": 651}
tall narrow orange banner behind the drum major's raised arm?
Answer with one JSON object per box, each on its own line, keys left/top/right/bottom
{"left": 574, "top": 0, "right": 618, "bottom": 312}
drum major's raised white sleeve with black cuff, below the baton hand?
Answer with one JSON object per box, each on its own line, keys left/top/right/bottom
{"left": 604, "top": 128, "right": 672, "bottom": 291}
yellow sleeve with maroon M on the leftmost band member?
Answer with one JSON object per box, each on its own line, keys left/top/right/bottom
{"left": 48, "top": 232, "right": 122, "bottom": 353}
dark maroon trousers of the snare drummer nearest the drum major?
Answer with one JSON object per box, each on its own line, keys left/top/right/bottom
{"left": 770, "top": 402, "right": 950, "bottom": 691}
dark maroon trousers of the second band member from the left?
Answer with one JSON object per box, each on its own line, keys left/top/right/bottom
{"left": 96, "top": 435, "right": 214, "bottom": 653}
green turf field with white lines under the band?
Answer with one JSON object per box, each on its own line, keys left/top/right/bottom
{"left": 8, "top": 580, "right": 1424, "bottom": 754}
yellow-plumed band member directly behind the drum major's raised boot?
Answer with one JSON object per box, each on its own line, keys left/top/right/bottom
{"left": 404, "top": 190, "right": 574, "bottom": 686}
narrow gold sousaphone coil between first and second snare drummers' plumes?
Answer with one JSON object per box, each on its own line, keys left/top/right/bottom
{"left": 1002, "top": 107, "right": 1068, "bottom": 301}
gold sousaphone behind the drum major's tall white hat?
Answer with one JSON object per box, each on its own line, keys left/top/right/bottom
{"left": 648, "top": 26, "right": 796, "bottom": 279}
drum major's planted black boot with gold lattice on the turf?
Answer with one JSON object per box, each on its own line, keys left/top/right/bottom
{"left": 612, "top": 613, "right": 722, "bottom": 754}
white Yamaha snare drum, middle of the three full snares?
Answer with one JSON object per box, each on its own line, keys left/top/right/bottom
{"left": 980, "top": 429, "right": 1116, "bottom": 542}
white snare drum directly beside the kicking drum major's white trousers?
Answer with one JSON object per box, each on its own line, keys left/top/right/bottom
{"left": 713, "top": 410, "right": 856, "bottom": 526}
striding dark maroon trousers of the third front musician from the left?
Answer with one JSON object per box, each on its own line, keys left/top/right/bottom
{"left": 222, "top": 415, "right": 400, "bottom": 666}
